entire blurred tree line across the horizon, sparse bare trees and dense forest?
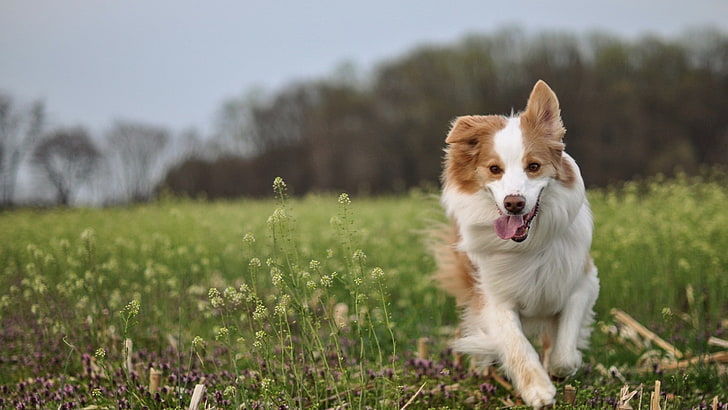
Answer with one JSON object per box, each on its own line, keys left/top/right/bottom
{"left": 0, "top": 29, "right": 728, "bottom": 208}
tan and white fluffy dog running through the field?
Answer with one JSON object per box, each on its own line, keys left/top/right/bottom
{"left": 435, "top": 80, "right": 599, "bottom": 408}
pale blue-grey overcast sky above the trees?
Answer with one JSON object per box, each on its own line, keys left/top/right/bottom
{"left": 0, "top": 0, "right": 728, "bottom": 132}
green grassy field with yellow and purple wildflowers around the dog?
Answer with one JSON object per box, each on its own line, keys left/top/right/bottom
{"left": 0, "top": 176, "right": 728, "bottom": 409}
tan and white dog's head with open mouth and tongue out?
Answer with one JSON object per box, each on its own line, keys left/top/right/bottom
{"left": 443, "top": 81, "right": 574, "bottom": 242}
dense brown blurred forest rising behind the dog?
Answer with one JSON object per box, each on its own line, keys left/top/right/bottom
{"left": 166, "top": 30, "right": 728, "bottom": 197}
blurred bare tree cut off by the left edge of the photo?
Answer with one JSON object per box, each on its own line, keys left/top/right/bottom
{"left": 0, "top": 94, "right": 45, "bottom": 208}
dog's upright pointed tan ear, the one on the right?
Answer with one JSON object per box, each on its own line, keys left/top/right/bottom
{"left": 521, "top": 80, "right": 566, "bottom": 141}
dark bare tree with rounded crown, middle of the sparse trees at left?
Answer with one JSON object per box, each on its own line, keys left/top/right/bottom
{"left": 33, "top": 127, "right": 101, "bottom": 206}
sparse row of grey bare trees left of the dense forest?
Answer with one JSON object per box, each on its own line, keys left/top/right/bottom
{"left": 0, "top": 93, "right": 196, "bottom": 209}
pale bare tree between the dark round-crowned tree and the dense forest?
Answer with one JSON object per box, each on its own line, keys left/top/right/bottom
{"left": 108, "top": 121, "right": 169, "bottom": 202}
